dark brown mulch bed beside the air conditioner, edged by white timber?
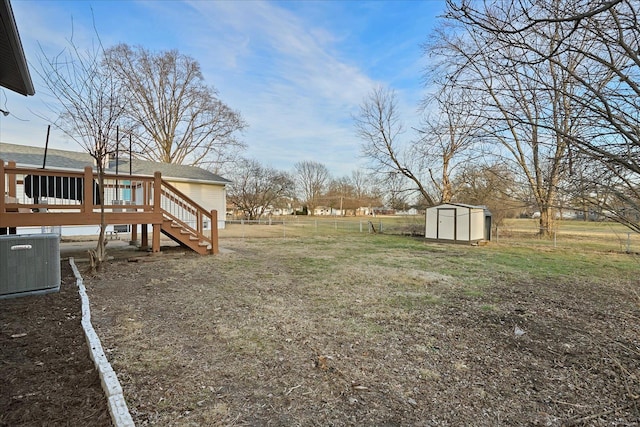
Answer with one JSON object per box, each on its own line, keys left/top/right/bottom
{"left": 0, "top": 262, "right": 111, "bottom": 426}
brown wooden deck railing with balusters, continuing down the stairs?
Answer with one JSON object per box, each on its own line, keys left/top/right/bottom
{"left": 0, "top": 159, "right": 217, "bottom": 251}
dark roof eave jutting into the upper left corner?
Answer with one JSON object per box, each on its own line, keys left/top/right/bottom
{"left": 0, "top": 0, "right": 36, "bottom": 95}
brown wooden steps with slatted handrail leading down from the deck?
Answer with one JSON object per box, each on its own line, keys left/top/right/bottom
{"left": 160, "top": 180, "right": 218, "bottom": 255}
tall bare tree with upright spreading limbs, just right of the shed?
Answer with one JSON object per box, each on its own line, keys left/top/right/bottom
{"left": 435, "top": 2, "right": 607, "bottom": 235}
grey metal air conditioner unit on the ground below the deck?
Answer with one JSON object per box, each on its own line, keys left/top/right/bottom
{"left": 0, "top": 233, "right": 60, "bottom": 298}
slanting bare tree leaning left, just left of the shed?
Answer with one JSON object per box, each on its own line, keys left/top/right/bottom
{"left": 353, "top": 87, "right": 435, "bottom": 205}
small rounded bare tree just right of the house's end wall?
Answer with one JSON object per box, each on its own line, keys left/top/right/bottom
{"left": 227, "top": 159, "right": 294, "bottom": 220}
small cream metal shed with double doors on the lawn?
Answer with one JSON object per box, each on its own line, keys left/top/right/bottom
{"left": 424, "top": 203, "right": 491, "bottom": 243}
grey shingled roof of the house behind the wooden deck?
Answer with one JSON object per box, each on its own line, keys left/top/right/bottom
{"left": 0, "top": 142, "right": 231, "bottom": 185}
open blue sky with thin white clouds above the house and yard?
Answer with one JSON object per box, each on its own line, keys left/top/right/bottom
{"left": 0, "top": 0, "right": 444, "bottom": 178}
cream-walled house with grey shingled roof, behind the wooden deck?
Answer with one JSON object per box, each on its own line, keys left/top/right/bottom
{"left": 0, "top": 143, "right": 231, "bottom": 235}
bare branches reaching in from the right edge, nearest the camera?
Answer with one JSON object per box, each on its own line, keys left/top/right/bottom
{"left": 448, "top": 0, "right": 640, "bottom": 232}
